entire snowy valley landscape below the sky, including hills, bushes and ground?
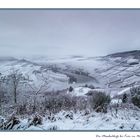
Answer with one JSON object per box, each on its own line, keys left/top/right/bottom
{"left": 0, "top": 50, "right": 140, "bottom": 131}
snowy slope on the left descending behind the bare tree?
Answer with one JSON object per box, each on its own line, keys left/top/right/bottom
{"left": 0, "top": 59, "right": 68, "bottom": 89}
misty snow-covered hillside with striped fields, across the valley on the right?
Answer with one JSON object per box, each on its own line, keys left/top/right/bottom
{"left": 22, "top": 50, "right": 140, "bottom": 97}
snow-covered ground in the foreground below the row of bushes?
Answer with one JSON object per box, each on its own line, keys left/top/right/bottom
{"left": 1, "top": 108, "right": 140, "bottom": 131}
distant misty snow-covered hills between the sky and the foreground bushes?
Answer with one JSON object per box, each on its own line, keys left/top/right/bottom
{"left": 0, "top": 51, "right": 140, "bottom": 94}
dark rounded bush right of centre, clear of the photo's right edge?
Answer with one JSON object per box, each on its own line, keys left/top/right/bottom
{"left": 90, "top": 91, "right": 111, "bottom": 113}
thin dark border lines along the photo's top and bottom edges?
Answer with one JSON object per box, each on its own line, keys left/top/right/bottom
{"left": 0, "top": 8, "right": 140, "bottom": 133}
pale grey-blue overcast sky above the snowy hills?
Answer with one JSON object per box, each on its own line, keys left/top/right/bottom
{"left": 0, "top": 10, "right": 140, "bottom": 56}
